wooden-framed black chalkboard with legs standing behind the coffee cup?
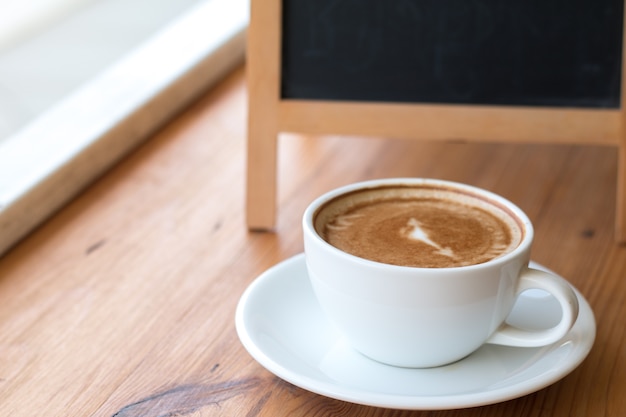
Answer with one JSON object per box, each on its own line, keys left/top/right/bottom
{"left": 246, "top": 0, "right": 626, "bottom": 243}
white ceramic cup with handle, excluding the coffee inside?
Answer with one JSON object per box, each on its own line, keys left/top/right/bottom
{"left": 302, "top": 178, "right": 578, "bottom": 368}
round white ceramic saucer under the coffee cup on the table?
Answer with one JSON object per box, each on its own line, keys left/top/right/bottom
{"left": 235, "top": 254, "right": 596, "bottom": 410}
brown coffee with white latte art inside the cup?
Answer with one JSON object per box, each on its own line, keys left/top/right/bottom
{"left": 314, "top": 185, "right": 524, "bottom": 268}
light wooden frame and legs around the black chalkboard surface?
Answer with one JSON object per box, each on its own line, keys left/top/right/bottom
{"left": 246, "top": 0, "right": 626, "bottom": 242}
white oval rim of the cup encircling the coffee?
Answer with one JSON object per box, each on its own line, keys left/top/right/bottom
{"left": 302, "top": 177, "right": 534, "bottom": 271}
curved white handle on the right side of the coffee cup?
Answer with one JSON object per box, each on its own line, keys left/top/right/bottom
{"left": 487, "top": 268, "right": 578, "bottom": 347}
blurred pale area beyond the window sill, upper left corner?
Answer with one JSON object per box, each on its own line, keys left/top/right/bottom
{"left": 0, "top": 0, "right": 202, "bottom": 141}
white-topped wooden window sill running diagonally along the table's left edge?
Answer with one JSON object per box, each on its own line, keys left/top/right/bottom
{"left": 0, "top": 0, "right": 248, "bottom": 256}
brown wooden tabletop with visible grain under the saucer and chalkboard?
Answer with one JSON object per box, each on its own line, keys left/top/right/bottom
{"left": 0, "top": 69, "right": 626, "bottom": 417}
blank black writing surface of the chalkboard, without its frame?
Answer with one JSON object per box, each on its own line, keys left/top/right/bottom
{"left": 280, "top": 0, "right": 623, "bottom": 108}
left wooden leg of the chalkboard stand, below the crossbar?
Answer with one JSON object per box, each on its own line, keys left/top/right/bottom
{"left": 246, "top": 127, "right": 277, "bottom": 230}
